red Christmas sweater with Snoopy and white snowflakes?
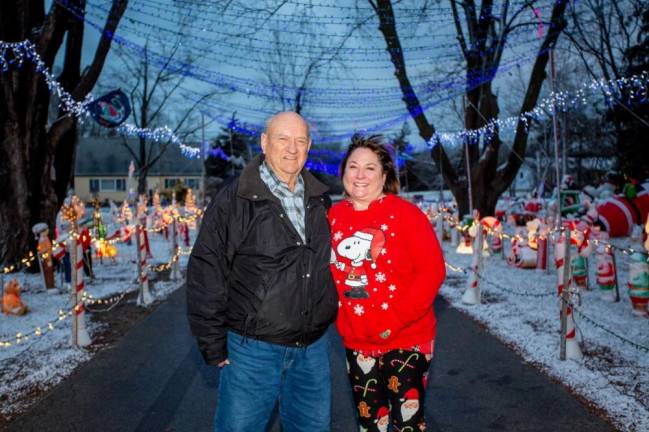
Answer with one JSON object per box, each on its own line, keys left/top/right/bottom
{"left": 329, "top": 195, "right": 446, "bottom": 352}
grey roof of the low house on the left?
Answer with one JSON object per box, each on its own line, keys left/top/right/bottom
{"left": 74, "top": 136, "right": 203, "bottom": 176}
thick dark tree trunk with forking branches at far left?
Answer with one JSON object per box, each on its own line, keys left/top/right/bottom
{"left": 0, "top": 0, "right": 128, "bottom": 264}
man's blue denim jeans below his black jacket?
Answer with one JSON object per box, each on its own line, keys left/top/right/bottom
{"left": 214, "top": 332, "right": 331, "bottom": 432}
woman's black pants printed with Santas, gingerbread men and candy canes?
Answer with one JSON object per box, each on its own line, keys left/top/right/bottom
{"left": 345, "top": 349, "right": 430, "bottom": 432}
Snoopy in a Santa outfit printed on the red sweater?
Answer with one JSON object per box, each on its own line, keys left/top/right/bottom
{"left": 332, "top": 228, "right": 385, "bottom": 299}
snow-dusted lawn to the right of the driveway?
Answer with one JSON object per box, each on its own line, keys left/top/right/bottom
{"left": 441, "top": 236, "right": 649, "bottom": 431}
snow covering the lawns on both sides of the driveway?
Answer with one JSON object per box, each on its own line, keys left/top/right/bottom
{"left": 0, "top": 202, "right": 649, "bottom": 431}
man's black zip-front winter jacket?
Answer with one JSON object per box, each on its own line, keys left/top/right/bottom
{"left": 187, "top": 156, "right": 338, "bottom": 365}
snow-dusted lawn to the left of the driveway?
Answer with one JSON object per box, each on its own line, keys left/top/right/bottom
{"left": 0, "top": 212, "right": 195, "bottom": 424}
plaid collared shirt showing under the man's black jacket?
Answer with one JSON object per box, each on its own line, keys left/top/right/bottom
{"left": 259, "top": 161, "right": 306, "bottom": 241}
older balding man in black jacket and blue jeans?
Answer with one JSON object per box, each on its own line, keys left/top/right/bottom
{"left": 187, "top": 112, "right": 338, "bottom": 432}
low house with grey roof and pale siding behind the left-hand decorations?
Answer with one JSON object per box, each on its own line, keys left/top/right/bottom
{"left": 74, "top": 136, "right": 203, "bottom": 202}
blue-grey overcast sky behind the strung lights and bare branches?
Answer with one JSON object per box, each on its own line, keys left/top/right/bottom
{"left": 54, "top": 0, "right": 572, "bottom": 149}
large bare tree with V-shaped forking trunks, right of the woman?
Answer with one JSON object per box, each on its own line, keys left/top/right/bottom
{"left": 367, "top": 0, "right": 568, "bottom": 215}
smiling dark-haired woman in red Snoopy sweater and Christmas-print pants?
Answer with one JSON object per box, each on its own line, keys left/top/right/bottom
{"left": 329, "top": 135, "right": 445, "bottom": 430}
